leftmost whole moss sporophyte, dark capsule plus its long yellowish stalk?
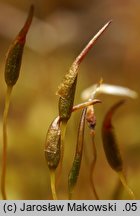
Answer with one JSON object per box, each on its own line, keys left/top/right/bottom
{"left": 1, "top": 5, "right": 34, "bottom": 200}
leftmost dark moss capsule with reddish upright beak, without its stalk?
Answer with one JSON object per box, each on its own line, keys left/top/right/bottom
{"left": 5, "top": 5, "right": 34, "bottom": 86}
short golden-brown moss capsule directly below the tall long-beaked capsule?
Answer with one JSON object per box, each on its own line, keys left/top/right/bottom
{"left": 44, "top": 117, "right": 61, "bottom": 169}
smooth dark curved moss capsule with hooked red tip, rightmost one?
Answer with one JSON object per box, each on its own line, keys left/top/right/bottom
{"left": 102, "top": 100, "right": 124, "bottom": 172}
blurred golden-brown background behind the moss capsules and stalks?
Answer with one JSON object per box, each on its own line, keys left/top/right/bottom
{"left": 0, "top": 0, "right": 140, "bottom": 199}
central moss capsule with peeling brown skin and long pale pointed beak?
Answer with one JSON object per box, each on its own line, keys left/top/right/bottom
{"left": 56, "top": 21, "right": 111, "bottom": 121}
